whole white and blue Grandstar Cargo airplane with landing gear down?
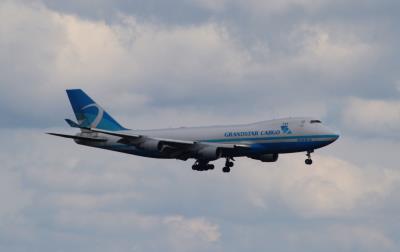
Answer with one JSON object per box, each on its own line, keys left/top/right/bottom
{"left": 47, "top": 89, "right": 339, "bottom": 173}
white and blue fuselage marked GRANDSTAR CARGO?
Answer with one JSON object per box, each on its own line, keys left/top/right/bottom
{"left": 80, "top": 118, "right": 339, "bottom": 158}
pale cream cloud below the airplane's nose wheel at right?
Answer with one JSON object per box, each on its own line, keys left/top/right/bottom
{"left": 282, "top": 157, "right": 400, "bottom": 217}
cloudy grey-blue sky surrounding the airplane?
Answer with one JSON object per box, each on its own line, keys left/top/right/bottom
{"left": 0, "top": 0, "right": 400, "bottom": 252}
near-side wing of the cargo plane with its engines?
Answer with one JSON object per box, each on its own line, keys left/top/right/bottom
{"left": 90, "top": 128, "right": 250, "bottom": 160}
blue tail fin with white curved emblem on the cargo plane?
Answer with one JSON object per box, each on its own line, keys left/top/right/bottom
{"left": 67, "top": 89, "right": 126, "bottom": 131}
